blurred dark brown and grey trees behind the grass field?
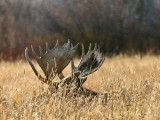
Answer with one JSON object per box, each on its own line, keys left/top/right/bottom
{"left": 0, "top": 0, "right": 160, "bottom": 60}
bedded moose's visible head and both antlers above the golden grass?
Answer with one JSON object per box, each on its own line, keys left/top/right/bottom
{"left": 25, "top": 41, "right": 106, "bottom": 103}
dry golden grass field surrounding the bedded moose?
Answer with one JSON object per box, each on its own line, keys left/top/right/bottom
{"left": 0, "top": 55, "right": 160, "bottom": 120}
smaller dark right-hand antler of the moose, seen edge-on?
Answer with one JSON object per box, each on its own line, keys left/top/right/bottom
{"left": 71, "top": 43, "right": 104, "bottom": 78}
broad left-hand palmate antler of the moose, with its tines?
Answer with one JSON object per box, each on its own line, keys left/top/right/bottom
{"left": 25, "top": 40, "right": 79, "bottom": 84}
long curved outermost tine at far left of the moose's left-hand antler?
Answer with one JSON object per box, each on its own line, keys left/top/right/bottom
{"left": 25, "top": 48, "right": 46, "bottom": 82}
